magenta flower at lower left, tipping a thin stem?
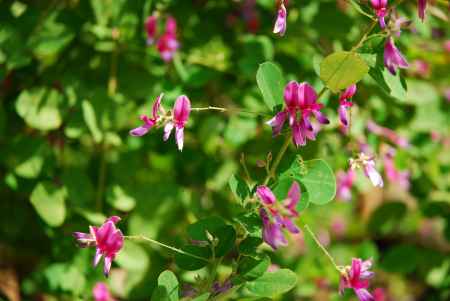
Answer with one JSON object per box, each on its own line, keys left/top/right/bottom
{"left": 73, "top": 216, "right": 124, "bottom": 277}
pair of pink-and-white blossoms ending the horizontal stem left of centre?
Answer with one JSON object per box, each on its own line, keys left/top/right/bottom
{"left": 130, "top": 94, "right": 191, "bottom": 151}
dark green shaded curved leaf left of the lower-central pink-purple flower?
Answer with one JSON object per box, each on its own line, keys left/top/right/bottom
{"left": 187, "top": 217, "right": 236, "bottom": 257}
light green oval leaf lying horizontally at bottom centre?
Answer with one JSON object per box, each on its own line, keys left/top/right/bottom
{"left": 244, "top": 269, "right": 297, "bottom": 297}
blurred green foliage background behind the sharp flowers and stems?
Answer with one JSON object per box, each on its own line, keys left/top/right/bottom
{"left": 0, "top": 0, "right": 450, "bottom": 301}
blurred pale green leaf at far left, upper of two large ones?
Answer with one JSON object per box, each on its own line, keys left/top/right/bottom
{"left": 16, "top": 88, "right": 62, "bottom": 131}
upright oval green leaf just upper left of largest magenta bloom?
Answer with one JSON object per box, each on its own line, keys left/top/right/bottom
{"left": 256, "top": 62, "right": 284, "bottom": 111}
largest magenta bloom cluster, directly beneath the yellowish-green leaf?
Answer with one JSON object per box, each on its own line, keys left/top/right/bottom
{"left": 267, "top": 81, "right": 329, "bottom": 147}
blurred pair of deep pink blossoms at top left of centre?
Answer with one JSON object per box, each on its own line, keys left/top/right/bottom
{"left": 145, "top": 14, "right": 180, "bottom": 62}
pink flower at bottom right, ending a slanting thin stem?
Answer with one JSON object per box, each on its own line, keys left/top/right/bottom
{"left": 339, "top": 258, "right": 374, "bottom": 301}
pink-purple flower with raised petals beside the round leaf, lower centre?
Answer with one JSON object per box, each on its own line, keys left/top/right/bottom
{"left": 256, "top": 182, "right": 301, "bottom": 250}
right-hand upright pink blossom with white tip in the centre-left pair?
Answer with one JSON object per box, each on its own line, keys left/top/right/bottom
{"left": 164, "top": 95, "right": 191, "bottom": 151}
